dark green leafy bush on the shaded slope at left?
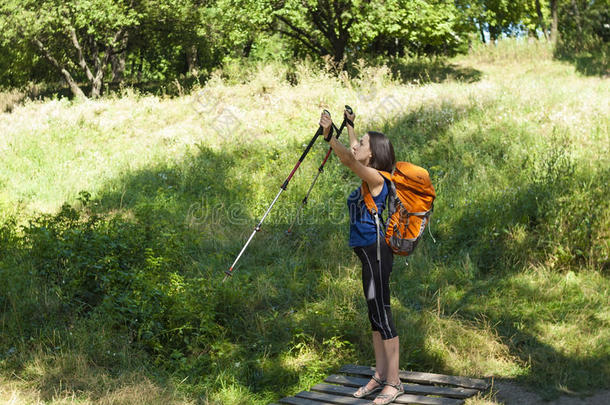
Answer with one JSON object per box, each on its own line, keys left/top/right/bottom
{"left": 5, "top": 193, "right": 215, "bottom": 355}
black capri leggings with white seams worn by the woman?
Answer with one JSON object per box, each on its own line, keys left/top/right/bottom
{"left": 354, "top": 240, "right": 398, "bottom": 340}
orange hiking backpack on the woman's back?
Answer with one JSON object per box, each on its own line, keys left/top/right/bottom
{"left": 362, "top": 162, "right": 436, "bottom": 260}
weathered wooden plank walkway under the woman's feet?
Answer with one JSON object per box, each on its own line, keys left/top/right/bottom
{"left": 272, "top": 365, "right": 489, "bottom": 405}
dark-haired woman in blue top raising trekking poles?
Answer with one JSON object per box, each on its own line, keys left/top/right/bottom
{"left": 320, "top": 110, "right": 404, "bottom": 404}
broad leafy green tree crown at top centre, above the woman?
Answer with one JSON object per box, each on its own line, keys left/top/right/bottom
{"left": 223, "top": 0, "right": 467, "bottom": 62}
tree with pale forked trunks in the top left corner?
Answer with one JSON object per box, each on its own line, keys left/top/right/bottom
{"left": 0, "top": 0, "right": 138, "bottom": 97}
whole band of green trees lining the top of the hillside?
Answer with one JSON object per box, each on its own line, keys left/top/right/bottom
{"left": 0, "top": 0, "right": 610, "bottom": 92}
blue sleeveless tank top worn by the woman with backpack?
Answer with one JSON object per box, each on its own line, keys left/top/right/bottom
{"left": 347, "top": 179, "right": 388, "bottom": 247}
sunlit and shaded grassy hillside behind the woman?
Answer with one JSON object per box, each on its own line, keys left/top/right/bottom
{"left": 0, "top": 41, "right": 610, "bottom": 404}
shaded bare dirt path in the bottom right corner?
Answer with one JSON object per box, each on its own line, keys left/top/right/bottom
{"left": 493, "top": 381, "right": 610, "bottom": 405}
